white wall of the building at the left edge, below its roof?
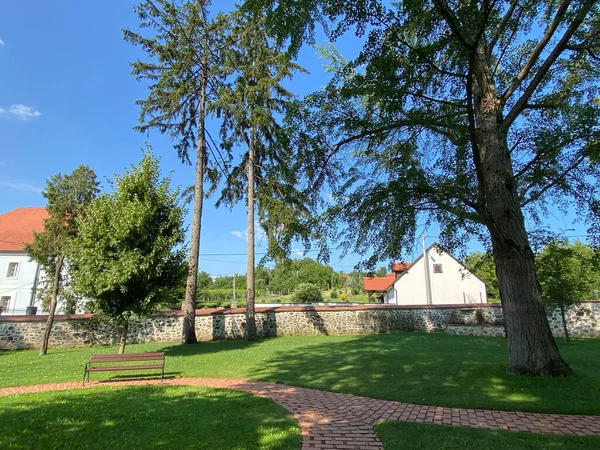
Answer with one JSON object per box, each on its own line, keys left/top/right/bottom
{"left": 0, "top": 252, "right": 37, "bottom": 314}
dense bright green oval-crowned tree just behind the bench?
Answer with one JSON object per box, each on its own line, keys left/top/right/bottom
{"left": 68, "top": 151, "right": 185, "bottom": 353}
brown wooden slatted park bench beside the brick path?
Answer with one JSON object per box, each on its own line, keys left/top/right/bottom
{"left": 83, "top": 352, "right": 165, "bottom": 384}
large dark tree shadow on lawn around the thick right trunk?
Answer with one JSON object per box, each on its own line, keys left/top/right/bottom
{"left": 252, "top": 333, "right": 600, "bottom": 414}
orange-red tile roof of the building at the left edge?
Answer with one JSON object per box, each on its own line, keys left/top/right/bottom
{"left": 0, "top": 208, "right": 48, "bottom": 252}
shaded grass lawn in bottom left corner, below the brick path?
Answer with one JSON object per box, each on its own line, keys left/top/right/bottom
{"left": 0, "top": 386, "right": 301, "bottom": 450}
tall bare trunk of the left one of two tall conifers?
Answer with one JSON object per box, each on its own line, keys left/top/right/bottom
{"left": 181, "top": 49, "right": 207, "bottom": 344}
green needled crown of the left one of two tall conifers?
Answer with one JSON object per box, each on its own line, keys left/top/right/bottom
{"left": 123, "top": 0, "right": 227, "bottom": 176}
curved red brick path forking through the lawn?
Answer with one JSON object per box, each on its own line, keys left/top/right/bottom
{"left": 0, "top": 378, "right": 600, "bottom": 450}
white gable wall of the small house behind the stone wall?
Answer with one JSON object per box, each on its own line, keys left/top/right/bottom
{"left": 385, "top": 247, "right": 487, "bottom": 305}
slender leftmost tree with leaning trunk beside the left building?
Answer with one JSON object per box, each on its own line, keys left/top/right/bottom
{"left": 25, "top": 165, "right": 98, "bottom": 355}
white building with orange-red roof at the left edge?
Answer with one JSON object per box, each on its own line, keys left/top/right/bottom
{"left": 0, "top": 208, "right": 48, "bottom": 314}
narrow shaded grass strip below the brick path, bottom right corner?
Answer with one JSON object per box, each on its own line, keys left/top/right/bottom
{"left": 375, "top": 422, "right": 600, "bottom": 450}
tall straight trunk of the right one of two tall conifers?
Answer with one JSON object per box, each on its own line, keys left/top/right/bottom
{"left": 245, "top": 130, "right": 256, "bottom": 341}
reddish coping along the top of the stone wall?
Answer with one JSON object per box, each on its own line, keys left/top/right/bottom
{"left": 0, "top": 303, "right": 501, "bottom": 322}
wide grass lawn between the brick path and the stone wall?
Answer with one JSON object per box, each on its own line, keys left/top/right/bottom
{"left": 0, "top": 333, "right": 600, "bottom": 414}
